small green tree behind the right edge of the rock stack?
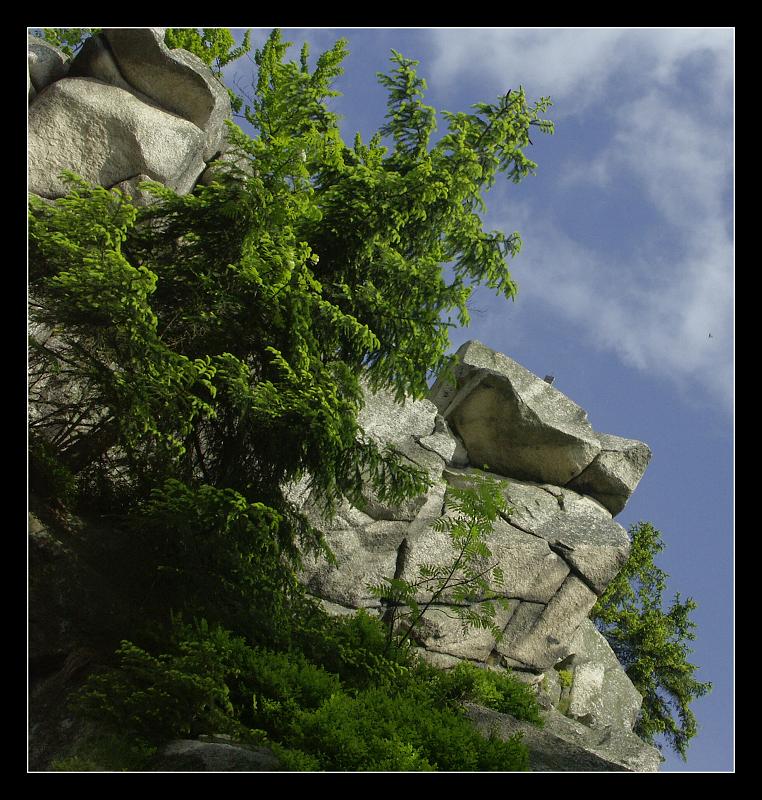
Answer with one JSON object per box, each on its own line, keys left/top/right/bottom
{"left": 591, "top": 522, "right": 712, "bottom": 760}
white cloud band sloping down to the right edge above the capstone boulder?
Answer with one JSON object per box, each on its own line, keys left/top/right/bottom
{"left": 498, "top": 209, "right": 733, "bottom": 408}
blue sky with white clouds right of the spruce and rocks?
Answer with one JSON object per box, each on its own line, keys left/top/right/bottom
{"left": 227, "top": 28, "right": 734, "bottom": 771}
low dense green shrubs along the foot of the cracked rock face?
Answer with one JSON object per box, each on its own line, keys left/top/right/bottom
{"left": 68, "top": 612, "right": 539, "bottom": 771}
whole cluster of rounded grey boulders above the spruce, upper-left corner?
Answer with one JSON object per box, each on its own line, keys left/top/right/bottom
{"left": 28, "top": 28, "right": 231, "bottom": 205}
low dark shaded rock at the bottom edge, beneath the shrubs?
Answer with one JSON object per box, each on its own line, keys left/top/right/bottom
{"left": 151, "top": 739, "right": 282, "bottom": 772}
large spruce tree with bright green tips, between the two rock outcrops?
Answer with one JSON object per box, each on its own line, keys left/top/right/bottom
{"left": 29, "top": 26, "right": 552, "bottom": 644}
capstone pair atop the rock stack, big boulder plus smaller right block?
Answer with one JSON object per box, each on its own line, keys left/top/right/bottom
{"left": 429, "top": 341, "right": 651, "bottom": 515}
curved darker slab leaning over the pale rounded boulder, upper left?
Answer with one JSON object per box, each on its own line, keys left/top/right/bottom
{"left": 103, "top": 28, "right": 231, "bottom": 159}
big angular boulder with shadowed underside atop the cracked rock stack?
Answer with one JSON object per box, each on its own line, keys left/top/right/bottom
{"left": 430, "top": 341, "right": 600, "bottom": 486}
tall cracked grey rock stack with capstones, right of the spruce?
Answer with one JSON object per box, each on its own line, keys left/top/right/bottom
{"left": 292, "top": 341, "right": 660, "bottom": 771}
